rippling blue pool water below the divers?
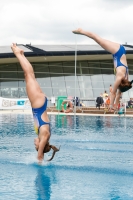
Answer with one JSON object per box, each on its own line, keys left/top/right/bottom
{"left": 0, "top": 114, "right": 133, "bottom": 200}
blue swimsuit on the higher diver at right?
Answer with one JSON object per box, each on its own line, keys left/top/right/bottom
{"left": 113, "top": 45, "right": 128, "bottom": 77}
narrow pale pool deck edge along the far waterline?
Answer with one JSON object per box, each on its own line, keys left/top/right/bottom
{"left": 0, "top": 110, "right": 133, "bottom": 117}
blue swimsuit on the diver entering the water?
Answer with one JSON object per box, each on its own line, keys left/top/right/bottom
{"left": 32, "top": 97, "right": 50, "bottom": 134}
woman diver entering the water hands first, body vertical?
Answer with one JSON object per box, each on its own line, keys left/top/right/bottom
{"left": 11, "top": 44, "right": 59, "bottom": 162}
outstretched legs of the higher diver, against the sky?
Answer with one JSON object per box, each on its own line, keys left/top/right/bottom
{"left": 73, "top": 28, "right": 120, "bottom": 54}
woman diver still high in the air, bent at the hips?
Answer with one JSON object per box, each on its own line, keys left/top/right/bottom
{"left": 72, "top": 28, "right": 132, "bottom": 110}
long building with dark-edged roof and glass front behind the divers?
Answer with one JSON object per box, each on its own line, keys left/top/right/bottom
{"left": 0, "top": 45, "right": 133, "bottom": 99}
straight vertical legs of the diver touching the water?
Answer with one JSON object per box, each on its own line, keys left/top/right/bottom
{"left": 11, "top": 44, "right": 44, "bottom": 107}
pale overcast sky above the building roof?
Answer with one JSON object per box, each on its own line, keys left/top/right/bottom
{"left": 0, "top": 0, "right": 133, "bottom": 46}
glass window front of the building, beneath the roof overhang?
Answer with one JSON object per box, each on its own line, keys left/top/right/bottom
{"left": 0, "top": 59, "right": 133, "bottom": 98}
